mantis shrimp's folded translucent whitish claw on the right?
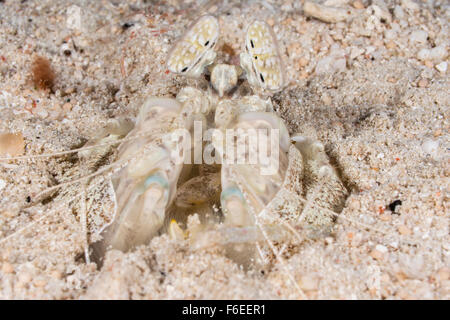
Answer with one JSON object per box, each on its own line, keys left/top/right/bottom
{"left": 221, "top": 112, "right": 289, "bottom": 266}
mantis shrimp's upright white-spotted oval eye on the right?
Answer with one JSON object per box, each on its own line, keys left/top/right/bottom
{"left": 245, "top": 21, "right": 284, "bottom": 91}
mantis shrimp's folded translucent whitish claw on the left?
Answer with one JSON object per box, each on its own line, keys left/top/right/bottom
{"left": 94, "top": 98, "right": 190, "bottom": 257}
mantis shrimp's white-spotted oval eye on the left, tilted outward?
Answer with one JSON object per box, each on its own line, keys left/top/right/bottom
{"left": 167, "top": 15, "right": 219, "bottom": 74}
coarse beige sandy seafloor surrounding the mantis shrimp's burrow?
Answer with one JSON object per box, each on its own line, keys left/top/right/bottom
{"left": 0, "top": 0, "right": 450, "bottom": 299}
